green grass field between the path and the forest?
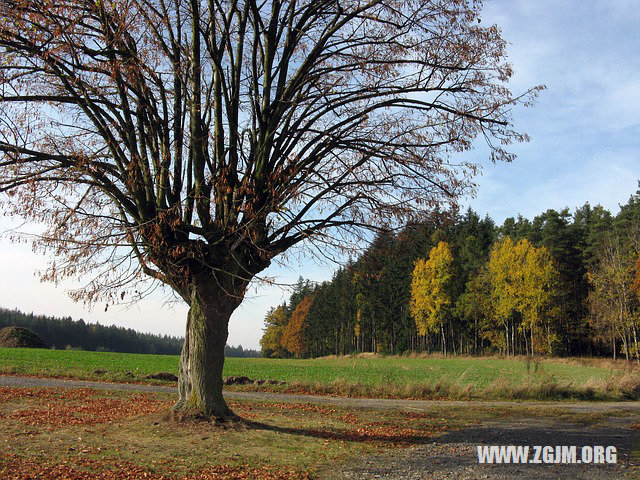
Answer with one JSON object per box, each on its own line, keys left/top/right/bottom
{"left": 0, "top": 348, "right": 640, "bottom": 399}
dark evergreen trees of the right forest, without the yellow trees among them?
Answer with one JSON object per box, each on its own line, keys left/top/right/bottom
{"left": 258, "top": 192, "right": 640, "bottom": 356}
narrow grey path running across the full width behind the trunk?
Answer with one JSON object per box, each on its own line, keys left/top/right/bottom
{"left": 0, "top": 375, "right": 640, "bottom": 413}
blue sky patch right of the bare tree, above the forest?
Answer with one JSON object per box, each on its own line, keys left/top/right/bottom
{"left": 470, "top": 0, "right": 640, "bottom": 222}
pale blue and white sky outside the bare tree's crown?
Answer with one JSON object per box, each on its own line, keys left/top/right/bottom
{"left": 0, "top": 0, "right": 640, "bottom": 348}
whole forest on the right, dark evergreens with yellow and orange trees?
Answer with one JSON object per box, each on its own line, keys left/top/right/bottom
{"left": 260, "top": 191, "right": 640, "bottom": 363}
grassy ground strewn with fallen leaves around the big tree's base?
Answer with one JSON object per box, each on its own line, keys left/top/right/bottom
{"left": 0, "top": 387, "right": 457, "bottom": 480}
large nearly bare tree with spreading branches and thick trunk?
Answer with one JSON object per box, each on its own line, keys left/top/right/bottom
{"left": 0, "top": 0, "right": 537, "bottom": 418}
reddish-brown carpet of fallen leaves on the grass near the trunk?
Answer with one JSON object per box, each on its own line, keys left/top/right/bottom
{"left": 0, "top": 387, "right": 450, "bottom": 480}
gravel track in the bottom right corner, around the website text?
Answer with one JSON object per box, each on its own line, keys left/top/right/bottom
{"left": 326, "top": 418, "right": 640, "bottom": 480}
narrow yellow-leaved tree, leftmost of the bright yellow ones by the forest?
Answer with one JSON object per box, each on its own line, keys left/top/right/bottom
{"left": 410, "top": 242, "right": 453, "bottom": 355}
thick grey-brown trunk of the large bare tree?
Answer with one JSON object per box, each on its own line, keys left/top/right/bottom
{"left": 173, "top": 282, "right": 244, "bottom": 420}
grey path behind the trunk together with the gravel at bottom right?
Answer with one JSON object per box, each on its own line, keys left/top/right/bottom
{"left": 5, "top": 376, "right": 640, "bottom": 480}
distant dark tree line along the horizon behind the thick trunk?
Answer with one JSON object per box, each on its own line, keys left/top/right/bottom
{"left": 0, "top": 308, "right": 260, "bottom": 357}
